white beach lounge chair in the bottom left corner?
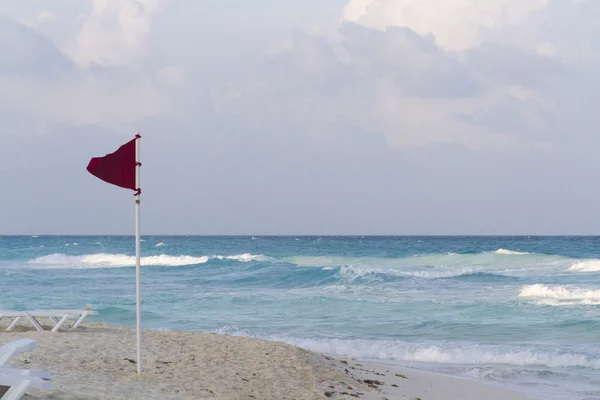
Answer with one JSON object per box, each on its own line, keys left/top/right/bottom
{"left": 0, "top": 339, "right": 52, "bottom": 400}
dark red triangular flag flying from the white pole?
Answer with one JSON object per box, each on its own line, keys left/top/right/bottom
{"left": 87, "top": 135, "right": 141, "bottom": 194}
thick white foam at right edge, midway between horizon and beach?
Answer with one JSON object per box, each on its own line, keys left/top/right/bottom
{"left": 519, "top": 283, "right": 600, "bottom": 307}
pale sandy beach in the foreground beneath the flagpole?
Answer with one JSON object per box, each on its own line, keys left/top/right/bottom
{"left": 0, "top": 323, "right": 540, "bottom": 400}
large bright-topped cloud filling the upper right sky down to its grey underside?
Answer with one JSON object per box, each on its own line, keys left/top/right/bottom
{"left": 209, "top": 0, "right": 600, "bottom": 150}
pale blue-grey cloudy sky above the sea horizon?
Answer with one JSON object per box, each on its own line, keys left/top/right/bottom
{"left": 0, "top": 0, "right": 600, "bottom": 235}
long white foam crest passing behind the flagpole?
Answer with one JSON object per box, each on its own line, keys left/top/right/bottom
{"left": 27, "top": 253, "right": 208, "bottom": 268}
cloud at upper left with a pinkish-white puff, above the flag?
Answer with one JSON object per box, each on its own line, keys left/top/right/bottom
{"left": 0, "top": 1, "right": 177, "bottom": 128}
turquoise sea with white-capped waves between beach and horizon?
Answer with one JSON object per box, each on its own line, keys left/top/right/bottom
{"left": 0, "top": 236, "right": 600, "bottom": 400}
